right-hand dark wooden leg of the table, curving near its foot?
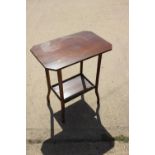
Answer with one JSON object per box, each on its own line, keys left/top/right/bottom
{"left": 95, "top": 54, "right": 102, "bottom": 110}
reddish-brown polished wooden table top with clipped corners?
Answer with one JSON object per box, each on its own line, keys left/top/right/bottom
{"left": 30, "top": 31, "right": 112, "bottom": 70}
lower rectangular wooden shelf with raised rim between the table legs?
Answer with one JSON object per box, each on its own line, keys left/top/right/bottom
{"left": 52, "top": 74, "right": 95, "bottom": 101}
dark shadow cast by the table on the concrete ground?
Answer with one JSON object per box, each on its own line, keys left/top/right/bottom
{"left": 41, "top": 100, "right": 114, "bottom": 155}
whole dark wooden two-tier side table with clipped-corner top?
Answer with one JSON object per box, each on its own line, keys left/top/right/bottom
{"left": 30, "top": 31, "right": 112, "bottom": 122}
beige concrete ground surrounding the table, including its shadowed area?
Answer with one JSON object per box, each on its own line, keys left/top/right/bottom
{"left": 26, "top": 0, "right": 129, "bottom": 155}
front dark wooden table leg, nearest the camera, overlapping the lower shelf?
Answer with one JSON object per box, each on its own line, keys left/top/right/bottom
{"left": 57, "top": 69, "right": 65, "bottom": 123}
